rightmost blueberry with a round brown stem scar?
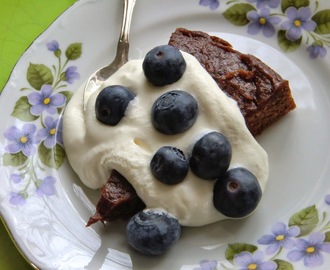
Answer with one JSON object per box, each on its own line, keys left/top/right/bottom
{"left": 213, "top": 168, "right": 262, "bottom": 218}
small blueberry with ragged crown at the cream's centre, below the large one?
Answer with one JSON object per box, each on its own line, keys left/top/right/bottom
{"left": 150, "top": 146, "right": 189, "bottom": 185}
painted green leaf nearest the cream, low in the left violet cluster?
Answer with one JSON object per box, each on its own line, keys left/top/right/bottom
{"left": 38, "top": 143, "right": 65, "bottom": 169}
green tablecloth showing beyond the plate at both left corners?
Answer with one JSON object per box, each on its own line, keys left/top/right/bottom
{"left": 0, "top": 0, "right": 76, "bottom": 270}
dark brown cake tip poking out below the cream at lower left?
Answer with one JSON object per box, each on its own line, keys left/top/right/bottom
{"left": 86, "top": 170, "right": 145, "bottom": 226}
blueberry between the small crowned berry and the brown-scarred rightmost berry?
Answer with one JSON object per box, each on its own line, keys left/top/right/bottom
{"left": 190, "top": 131, "right": 232, "bottom": 180}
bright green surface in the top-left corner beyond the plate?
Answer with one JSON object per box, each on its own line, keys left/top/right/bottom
{"left": 0, "top": 0, "right": 75, "bottom": 92}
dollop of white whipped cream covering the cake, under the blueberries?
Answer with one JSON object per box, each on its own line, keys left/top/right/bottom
{"left": 63, "top": 52, "right": 268, "bottom": 226}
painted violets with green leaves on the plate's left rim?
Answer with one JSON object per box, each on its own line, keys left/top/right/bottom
{"left": 3, "top": 40, "right": 82, "bottom": 205}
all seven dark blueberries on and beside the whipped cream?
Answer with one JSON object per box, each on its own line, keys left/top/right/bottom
{"left": 95, "top": 45, "right": 261, "bottom": 255}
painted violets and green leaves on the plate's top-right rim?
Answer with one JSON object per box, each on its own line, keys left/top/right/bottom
{"left": 199, "top": 0, "right": 330, "bottom": 59}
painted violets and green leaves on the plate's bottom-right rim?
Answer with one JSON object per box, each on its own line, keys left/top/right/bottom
{"left": 194, "top": 194, "right": 330, "bottom": 270}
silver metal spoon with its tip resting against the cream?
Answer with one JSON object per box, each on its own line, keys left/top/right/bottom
{"left": 83, "top": 0, "right": 136, "bottom": 111}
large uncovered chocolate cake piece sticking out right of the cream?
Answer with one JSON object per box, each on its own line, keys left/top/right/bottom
{"left": 169, "top": 28, "right": 296, "bottom": 136}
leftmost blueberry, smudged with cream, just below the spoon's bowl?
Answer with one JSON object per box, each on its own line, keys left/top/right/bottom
{"left": 95, "top": 85, "right": 134, "bottom": 126}
